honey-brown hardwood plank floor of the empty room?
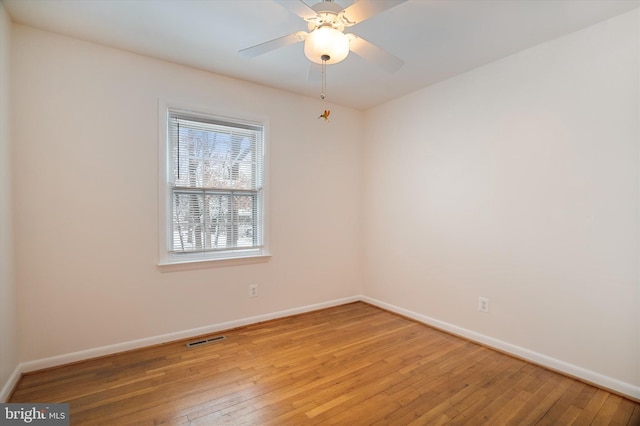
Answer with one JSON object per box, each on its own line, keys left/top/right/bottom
{"left": 10, "top": 302, "right": 640, "bottom": 425}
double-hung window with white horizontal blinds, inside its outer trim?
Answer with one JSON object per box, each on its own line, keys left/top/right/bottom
{"left": 161, "top": 109, "right": 266, "bottom": 263}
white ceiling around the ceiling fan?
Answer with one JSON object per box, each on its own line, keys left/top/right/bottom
{"left": 2, "top": 0, "right": 640, "bottom": 109}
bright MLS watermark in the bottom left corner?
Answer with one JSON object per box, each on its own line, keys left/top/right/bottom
{"left": 0, "top": 403, "right": 69, "bottom": 426}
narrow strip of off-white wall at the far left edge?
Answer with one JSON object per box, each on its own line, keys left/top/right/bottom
{"left": 0, "top": 3, "right": 18, "bottom": 401}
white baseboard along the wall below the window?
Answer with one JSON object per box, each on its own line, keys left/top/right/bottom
{"left": 19, "top": 296, "right": 361, "bottom": 373}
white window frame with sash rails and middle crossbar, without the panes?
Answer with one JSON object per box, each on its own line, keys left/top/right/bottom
{"left": 158, "top": 99, "right": 271, "bottom": 269}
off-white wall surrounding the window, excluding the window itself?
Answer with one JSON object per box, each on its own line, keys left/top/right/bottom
{"left": 11, "top": 25, "right": 363, "bottom": 362}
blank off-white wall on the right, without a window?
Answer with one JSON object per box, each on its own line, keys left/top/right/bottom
{"left": 364, "top": 9, "right": 640, "bottom": 397}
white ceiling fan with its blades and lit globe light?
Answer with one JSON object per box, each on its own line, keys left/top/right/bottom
{"left": 239, "top": 0, "right": 407, "bottom": 73}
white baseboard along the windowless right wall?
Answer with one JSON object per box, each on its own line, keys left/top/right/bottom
{"left": 360, "top": 296, "right": 640, "bottom": 400}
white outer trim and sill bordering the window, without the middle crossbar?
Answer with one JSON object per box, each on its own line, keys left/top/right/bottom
{"left": 158, "top": 98, "right": 271, "bottom": 271}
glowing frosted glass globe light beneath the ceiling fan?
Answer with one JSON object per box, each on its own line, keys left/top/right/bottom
{"left": 304, "top": 26, "right": 349, "bottom": 65}
